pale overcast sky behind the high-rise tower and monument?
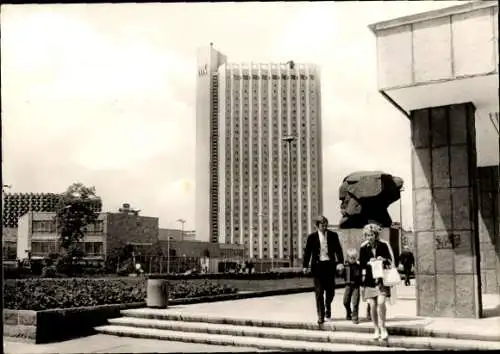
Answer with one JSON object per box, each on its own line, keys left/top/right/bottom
{"left": 1, "top": 1, "right": 461, "bottom": 235}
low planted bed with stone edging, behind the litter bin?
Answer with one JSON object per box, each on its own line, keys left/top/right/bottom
{"left": 3, "top": 276, "right": 328, "bottom": 343}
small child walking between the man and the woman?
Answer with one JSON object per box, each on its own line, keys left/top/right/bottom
{"left": 344, "top": 248, "right": 362, "bottom": 324}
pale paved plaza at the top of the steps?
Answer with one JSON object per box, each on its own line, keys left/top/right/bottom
{"left": 133, "top": 280, "right": 500, "bottom": 340}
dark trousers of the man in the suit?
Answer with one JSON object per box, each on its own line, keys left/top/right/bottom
{"left": 313, "top": 261, "right": 335, "bottom": 319}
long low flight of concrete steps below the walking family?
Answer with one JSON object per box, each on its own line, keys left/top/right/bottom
{"left": 96, "top": 309, "right": 500, "bottom": 351}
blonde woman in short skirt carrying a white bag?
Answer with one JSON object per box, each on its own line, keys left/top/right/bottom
{"left": 359, "top": 224, "right": 394, "bottom": 340}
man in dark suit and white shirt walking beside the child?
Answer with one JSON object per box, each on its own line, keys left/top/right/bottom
{"left": 303, "top": 216, "right": 344, "bottom": 324}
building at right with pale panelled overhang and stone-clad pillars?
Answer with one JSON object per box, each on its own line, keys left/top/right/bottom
{"left": 370, "top": 1, "right": 500, "bottom": 317}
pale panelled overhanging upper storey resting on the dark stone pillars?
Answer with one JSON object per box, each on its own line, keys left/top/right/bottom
{"left": 370, "top": 1, "right": 499, "bottom": 166}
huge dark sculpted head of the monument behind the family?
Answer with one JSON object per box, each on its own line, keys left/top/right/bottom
{"left": 339, "top": 171, "right": 403, "bottom": 229}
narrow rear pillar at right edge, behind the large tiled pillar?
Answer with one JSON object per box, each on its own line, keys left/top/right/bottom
{"left": 478, "top": 166, "right": 500, "bottom": 294}
